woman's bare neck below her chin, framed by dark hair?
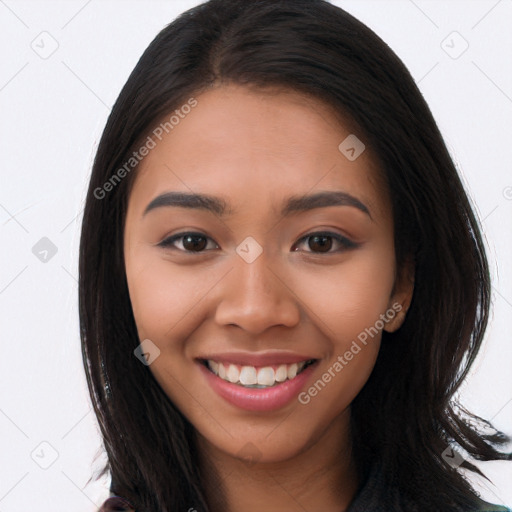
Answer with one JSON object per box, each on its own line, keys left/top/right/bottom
{"left": 198, "top": 410, "right": 358, "bottom": 512}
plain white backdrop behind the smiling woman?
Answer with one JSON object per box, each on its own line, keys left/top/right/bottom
{"left": 0, "top": 0, "right": 512, "bottom": 512}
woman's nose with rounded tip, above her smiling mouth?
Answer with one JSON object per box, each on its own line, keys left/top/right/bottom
{"left": 215, "top": 252, "right": 301, "bottom": 334}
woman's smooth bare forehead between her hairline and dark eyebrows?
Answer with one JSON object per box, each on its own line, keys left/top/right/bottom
{"left": 127, "top": 85, "right": 388, "bottom": 219}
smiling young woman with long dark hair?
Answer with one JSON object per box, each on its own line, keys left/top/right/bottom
{"left": 79, "top": 0, "right": 512, "bottom": 512}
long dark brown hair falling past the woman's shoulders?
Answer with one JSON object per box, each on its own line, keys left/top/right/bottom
{"left": 79, "top": 0, "right": 512, "bottom": 512}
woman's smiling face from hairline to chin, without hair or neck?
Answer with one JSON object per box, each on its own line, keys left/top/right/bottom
{"left": 124, "top": 85, "right": 411, "bottom": 462}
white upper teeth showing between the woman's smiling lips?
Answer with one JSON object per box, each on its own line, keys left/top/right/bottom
{"left": 200, "top": 359, "right": 318, "bottom": 389}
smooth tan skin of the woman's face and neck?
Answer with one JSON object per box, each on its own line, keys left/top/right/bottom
{"left": 124, "top": 84, "right": 413, "bottom": 512}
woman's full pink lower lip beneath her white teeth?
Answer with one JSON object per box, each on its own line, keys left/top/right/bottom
{"left": 198, "top": 361, "right": 318, "bottom": 411}
